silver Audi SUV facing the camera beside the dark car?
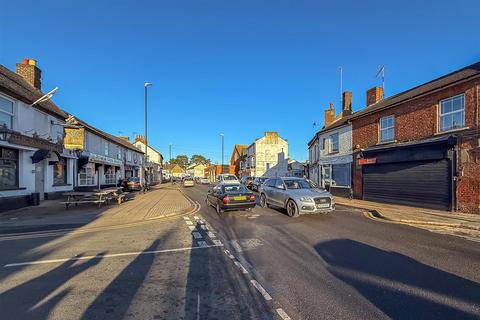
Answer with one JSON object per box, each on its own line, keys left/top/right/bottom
{"left": 260, "top": 177, "right": 335, "bottom": 217}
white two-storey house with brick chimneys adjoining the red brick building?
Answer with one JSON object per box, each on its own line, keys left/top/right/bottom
{"left": 308, "top": 91, "right": 353, "bottom": 196}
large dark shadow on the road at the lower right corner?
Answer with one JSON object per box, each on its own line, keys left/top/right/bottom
{"left": 315, "top": 239, "right": 480, "bottom": 319}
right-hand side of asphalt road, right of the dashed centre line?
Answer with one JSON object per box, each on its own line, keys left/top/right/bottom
{"left": 185, "top": 186, "right": 480, "bottom": 319}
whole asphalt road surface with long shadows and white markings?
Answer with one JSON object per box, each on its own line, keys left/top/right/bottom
{"left": 0, "top": 185, "right": 480, "bottom": 319}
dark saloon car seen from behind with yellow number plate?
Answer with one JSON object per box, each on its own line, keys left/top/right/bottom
{"left": 205, "top": 183, "right": 255, "bottom": 214}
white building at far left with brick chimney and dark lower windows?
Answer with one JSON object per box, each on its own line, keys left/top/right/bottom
{"left": 0, "top": 59, "right": 76, "bottom": 211}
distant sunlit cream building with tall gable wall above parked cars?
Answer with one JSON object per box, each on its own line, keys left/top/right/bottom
{"left": 239, "top": 132, "right": 288, "bottom": 177}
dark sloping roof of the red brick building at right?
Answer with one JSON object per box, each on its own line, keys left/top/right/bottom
{"left": 355, "top": 62, "right": 480, "bottom": 118}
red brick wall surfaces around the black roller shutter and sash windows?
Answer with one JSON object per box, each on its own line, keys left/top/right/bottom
{"left": 352, "top": 79, "right": 480, "bottom": 212}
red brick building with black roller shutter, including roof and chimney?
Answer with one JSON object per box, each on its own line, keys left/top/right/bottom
{"left": 351, "top": 62, "right": 480, "bottom": 213}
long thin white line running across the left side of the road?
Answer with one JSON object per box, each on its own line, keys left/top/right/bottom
{"left": 3, "top": 245, "right": 224, "bottom": 268}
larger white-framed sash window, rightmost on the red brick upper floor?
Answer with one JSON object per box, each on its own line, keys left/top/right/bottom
{"left": 439, "top": 94, "right": 465, "bottom": 132}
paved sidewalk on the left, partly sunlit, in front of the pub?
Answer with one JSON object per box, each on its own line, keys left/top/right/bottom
{"left": 0, "top": 185, "right": 194, "bottom": 233}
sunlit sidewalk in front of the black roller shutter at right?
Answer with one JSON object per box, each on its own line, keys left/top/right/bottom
{"left": 335, "top": 197, "right": 480, "bottom": 241}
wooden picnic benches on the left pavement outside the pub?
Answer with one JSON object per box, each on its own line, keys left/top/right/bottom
{"left": 61, "top": 188, "right": 129, "bottom": 209}
